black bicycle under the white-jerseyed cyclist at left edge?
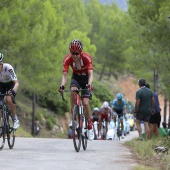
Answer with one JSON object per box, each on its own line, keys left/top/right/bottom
{"left": 0, "top": 94, "right": 16, "bottom": 150}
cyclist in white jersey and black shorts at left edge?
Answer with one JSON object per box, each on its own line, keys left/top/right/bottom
{"left": 0, "top": 53, "right": 20, "bottom": 129}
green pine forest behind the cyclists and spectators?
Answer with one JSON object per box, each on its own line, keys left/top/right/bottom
{"left": 0, "top": 0, "right": 170, "bottom": 113}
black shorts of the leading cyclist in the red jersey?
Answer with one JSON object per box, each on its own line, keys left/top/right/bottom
{"left": 70, "top": 74, "right": 92, "bottom": 99}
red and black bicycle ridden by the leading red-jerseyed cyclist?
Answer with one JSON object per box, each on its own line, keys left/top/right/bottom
{"left": 60, "top": 89, "right": 88, "bottom": 152}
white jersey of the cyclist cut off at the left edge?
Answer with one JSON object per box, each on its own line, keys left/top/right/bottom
{"left": 0, "top": 63, "right": 17, "bottom": 83}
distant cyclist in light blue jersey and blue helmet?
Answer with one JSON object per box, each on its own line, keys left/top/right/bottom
{"left": 112, "top": 93, "right": 126, "bottom": 139}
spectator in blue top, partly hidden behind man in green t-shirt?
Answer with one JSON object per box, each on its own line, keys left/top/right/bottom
{"left": 145, "top": 84, "right": 161, "bottom": 137}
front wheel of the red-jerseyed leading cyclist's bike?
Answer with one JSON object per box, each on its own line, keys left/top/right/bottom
{"left": 72, "top": 105, "right": 82, "bottom": 152}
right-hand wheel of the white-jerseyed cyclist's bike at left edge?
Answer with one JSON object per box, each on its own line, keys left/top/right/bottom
{"left": 6, "top": 125, "right": 15, "bottom": 149}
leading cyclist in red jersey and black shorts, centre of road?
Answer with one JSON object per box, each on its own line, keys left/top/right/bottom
{"left": 58, "top": 39, "right": 94, "bottom": 140}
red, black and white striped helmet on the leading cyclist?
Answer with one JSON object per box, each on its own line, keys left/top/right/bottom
{"left": 69, "top": 39, "right": 83, "bottom": 53}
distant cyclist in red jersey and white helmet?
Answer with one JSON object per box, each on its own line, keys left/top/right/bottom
{"left": 98, "top": 101, "right": 112, "bottom": 137}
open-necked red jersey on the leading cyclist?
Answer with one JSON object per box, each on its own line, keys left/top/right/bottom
{"left": 63, "top": 52, "right": 93, "bottom": 75}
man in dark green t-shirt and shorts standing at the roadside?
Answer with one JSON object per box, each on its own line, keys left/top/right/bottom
{"left": 134, "top": 78, "right": 155, "bottom": 140}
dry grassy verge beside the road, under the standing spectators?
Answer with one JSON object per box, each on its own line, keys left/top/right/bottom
{"left": 125, "top": 137, "right": 170, "bottom": 170}
